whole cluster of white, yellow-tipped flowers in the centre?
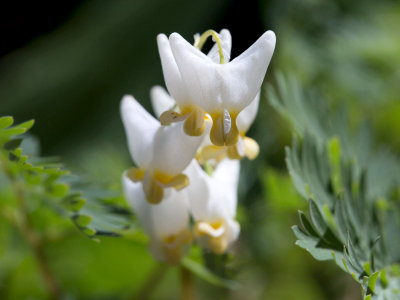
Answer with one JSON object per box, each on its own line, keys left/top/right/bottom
{"left": 121, "top": 29, "right": 275, "bottom": 264}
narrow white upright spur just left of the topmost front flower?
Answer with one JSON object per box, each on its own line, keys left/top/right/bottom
{"left": 157, "top": 34, "right": 191, "bottom": 106}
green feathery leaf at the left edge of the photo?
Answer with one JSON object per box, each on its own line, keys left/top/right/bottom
{"left": 0, "top": 117, "right": 131, "bottom": 238}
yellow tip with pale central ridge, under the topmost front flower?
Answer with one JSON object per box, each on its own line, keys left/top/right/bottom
{"left": 210, "top": 109, "right": 239, "bottom": 146}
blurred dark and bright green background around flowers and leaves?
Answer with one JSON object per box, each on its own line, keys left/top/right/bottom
{"left": 0, "top": 0, "right": 400, "bottom": 300}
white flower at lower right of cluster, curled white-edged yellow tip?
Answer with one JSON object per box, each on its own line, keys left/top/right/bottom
{"left": 186, "top": 159, "right": 240, "bottom": 254}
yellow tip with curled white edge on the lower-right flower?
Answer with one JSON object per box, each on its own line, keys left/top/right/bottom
{"left": 194, "top": 221, "right": 228, "bottom": 254}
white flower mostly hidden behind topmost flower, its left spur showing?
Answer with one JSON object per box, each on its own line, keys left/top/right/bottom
{"left": 157, "top": 29, "right": 232, "bottom": 136}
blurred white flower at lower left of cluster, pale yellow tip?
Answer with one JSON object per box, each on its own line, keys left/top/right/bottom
{"left": 122, "top": 172, "right": 192, "bottom": 264}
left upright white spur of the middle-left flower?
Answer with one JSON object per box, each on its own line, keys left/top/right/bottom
{"left": 120, "top": 95, "right": 160, "bottom": 168}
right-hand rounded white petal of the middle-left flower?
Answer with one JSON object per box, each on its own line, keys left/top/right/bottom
{"left": 151, "top": 122, "right": 209, "bottom": 175}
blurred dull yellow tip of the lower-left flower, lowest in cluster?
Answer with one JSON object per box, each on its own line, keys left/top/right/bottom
{"left": 162, "top": 228, "right": 192, "bottom": 265}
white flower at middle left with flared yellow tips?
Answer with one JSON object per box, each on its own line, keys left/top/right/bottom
{"left": 121, "top": 96, "right": 208, "bottom": 204}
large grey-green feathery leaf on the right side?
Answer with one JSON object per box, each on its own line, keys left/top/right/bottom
{"left": 268, "top": 75, "right": 400, "bottom": 299}
